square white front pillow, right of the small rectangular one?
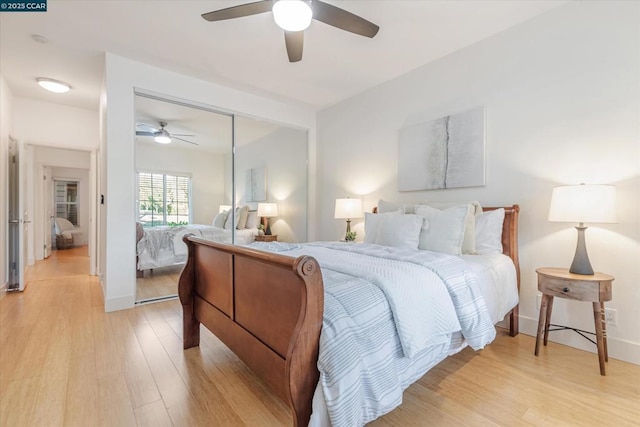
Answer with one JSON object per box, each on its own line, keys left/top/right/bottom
{"left": 416, "top": 205, "right": 471, "bottom": 255}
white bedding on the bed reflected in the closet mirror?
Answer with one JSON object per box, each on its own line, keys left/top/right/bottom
{"left": 136, "top": 224, "right": 258, "bottom": 270}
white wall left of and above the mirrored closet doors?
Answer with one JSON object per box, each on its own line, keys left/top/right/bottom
{"left": 100, "top": 53, "right": 316, "bottom": 311}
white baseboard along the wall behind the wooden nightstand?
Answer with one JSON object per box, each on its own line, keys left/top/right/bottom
{"left": 520, "top": 316, "right": 640, "bottom": 365}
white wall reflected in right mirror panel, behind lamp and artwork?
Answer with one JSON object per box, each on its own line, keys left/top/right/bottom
{"left": 235, "top": 128, "right": 307, "bottom": 242}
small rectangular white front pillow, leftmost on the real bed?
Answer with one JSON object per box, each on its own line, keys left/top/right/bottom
{"left": 376, "top": 214, "right": 423, "bottom": 249}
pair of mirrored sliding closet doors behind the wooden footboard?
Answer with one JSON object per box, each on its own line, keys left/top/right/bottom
{"left": 135, "top": 93, "right": 308, "bottom": 303}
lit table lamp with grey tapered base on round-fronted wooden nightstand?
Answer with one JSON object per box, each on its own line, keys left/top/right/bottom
{"left": 549, "top": 184, "right": 617, "bottom": 275}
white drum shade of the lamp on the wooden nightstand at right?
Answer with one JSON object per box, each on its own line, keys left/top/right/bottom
{"left": 549, "top": 184, "right": 617, "bottom": 223}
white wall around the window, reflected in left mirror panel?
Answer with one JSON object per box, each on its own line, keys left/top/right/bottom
{"left": 136, "top": 143, "right": 225, "bottom": 225}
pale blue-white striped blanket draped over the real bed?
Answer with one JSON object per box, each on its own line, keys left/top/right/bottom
{"left": 253, "top": 243, "right": 495, "bottom": 426}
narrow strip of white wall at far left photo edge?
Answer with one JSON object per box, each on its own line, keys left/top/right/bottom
{"left": 0, "top": 75, "right": 14, "bottom": 291}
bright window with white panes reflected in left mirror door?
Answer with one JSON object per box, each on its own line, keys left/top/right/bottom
{"left": 137, "top": 172, "right": 191, "bottom": 227}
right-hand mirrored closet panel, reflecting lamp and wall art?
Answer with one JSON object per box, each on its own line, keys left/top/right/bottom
{"left": 235, "top": 116, "right": 308, "bottom": 243}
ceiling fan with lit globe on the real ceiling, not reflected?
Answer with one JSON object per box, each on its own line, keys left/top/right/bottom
{"left": 202, "top": 0, "right": 380, "bottom": 62}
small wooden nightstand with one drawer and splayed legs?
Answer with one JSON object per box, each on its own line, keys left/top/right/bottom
{"left": 535, "top": 267, "right": 614, "bottom": 375}
